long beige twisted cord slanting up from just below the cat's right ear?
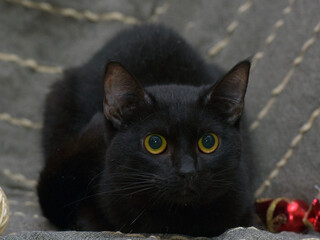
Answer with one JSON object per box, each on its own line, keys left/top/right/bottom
{"left": 250, "top": 21, "right": 320, "bottom": 131}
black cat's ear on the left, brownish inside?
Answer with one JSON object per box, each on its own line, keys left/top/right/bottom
{"left": 103, "top": 62, "right": 151, "bottom": 127}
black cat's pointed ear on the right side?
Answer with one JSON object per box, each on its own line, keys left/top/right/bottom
{"left": 205, "top": 60, "right": 250, "bottom": 124}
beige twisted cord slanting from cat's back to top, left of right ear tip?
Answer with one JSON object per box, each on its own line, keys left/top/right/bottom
{"left": 208, "top": 0, "right": 254, "bottom": 57}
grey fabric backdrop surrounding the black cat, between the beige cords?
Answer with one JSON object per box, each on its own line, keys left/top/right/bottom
{"left": 0, "top": 0, "right": 320, "bottom": 239}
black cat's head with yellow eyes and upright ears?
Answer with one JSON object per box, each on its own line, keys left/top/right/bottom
{"left": 101, "top": 61, "right": 250, "bottom": 204}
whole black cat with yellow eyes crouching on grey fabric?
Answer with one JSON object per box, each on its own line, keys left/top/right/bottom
{"left": 38, "top": 25, "right": 252, "bottom": 236}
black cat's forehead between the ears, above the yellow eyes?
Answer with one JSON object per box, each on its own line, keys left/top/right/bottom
{"left": 143, "top": 85, "right": 223, "bottom": 136}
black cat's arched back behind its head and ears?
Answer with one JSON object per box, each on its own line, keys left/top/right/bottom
{"left": 43, "top": 24, "right": 221, "bottom": 157}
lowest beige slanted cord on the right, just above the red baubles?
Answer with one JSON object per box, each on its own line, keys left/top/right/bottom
{"left": 255, "top": 104, "right": 320, "bottom": 198}
